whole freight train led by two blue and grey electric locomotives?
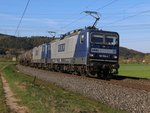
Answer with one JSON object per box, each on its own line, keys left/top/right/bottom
{"left": 19, "top": 11, "right": 119, "bottom": 78}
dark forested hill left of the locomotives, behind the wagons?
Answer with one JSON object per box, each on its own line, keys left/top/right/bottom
{"left": 0, "top": 34, "right": 52, "bottom": 50}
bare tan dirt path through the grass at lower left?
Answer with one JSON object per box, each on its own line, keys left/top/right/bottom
{"left": 1, "top": 76, "right": 29, "bottom": 113}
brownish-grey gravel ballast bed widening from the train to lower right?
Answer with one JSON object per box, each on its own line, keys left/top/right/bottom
{"left": 17, "top": 65, "right": 150, "bottom": 113}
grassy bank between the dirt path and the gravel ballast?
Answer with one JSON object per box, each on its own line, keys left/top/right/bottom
{"left": 2, "top": 61, "right": 126, "bottom": 113}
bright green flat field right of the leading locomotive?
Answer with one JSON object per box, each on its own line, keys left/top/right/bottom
{"left": 119, "top": 64, "right": 150, "bottom": 78}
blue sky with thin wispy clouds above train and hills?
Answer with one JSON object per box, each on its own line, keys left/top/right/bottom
{"left": 0, "top": 0, "right": 150, "bottom": 53}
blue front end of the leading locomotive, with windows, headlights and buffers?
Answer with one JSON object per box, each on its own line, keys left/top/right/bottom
{"left": 87, "top": 29, "right": 119, "bottom": 78}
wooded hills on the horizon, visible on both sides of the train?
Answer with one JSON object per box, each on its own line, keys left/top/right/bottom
{"left": 0, "top": 34, "right": 150, "bottom": 63}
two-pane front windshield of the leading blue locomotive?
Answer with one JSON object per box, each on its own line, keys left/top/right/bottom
{"left": 91, "top": 34, "right": 118, "bottom": 45}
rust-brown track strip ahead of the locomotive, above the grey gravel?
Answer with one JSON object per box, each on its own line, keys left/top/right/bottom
{"left": 64, "top": 75, "right": 150, "bottom": 92}
